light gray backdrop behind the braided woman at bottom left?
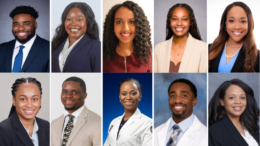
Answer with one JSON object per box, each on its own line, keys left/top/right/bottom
{"left": 0, "top": 73, "right": 50, "bottom": 122}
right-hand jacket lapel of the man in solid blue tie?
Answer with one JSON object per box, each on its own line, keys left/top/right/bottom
{"left": 21, "top": 35, "right": 42, "bottom": 72}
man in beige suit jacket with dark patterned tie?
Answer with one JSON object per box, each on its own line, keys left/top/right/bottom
{"left": 51, "top": 77, "right": 101, "bottom": 146}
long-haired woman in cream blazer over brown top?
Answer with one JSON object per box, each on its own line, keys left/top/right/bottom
{"left": 154, "top": 3, "right": 207, "bottom": 73}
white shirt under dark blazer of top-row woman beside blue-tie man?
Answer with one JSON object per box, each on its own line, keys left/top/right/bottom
{"left": 59, "top": 35, "right": 84, "bottom": 72}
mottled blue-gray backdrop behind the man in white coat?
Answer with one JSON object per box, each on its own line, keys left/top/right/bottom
{"left": 154, "top": 73, "right": 207, "bottom": 128}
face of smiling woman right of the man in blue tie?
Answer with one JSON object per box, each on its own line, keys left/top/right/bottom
{"left": 64, "top": 8, "right": 87, "bottom": 40}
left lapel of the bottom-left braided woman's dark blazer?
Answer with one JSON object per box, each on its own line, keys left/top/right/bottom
{"left": 10, "top": 112, "right": 34, "bottom": 146}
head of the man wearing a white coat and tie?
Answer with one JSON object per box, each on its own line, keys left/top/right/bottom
{"left": 168, "top": 82, "right": 197, "bottom": 123}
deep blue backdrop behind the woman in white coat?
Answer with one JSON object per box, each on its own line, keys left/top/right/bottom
{"left": 103, "top": 73, "right": 152, "bottom": 144}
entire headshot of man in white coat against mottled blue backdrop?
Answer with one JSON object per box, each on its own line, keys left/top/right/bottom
{"left": 154, "top": 73, "right": 208, "bottom": 146}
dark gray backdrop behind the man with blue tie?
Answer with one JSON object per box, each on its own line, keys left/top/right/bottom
{"left": 0, "top": 0, "right": 50, "bottom": 44}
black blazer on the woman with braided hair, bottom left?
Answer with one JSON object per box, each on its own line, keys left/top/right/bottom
{"left": 0, "top": 112, "right": 50, "bottom": 146}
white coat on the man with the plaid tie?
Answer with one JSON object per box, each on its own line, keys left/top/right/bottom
{"left": 154, "top": 116, "right": 208, "bottom": 146}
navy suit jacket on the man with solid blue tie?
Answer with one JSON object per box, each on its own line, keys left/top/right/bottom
{"left": 0, "top": 35, "right": 50, "bottom": 72}
